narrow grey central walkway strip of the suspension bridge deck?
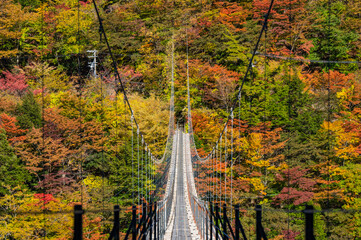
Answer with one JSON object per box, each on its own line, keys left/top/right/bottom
{"left": 172, "top": 133, "right": 192, "bottom": 240}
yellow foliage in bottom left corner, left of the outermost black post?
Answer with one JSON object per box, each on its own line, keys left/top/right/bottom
{"left": 0, "top": 187, "right": 72, "bottom": 239}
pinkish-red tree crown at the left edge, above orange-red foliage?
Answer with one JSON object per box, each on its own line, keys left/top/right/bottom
{"left": 0, "top": 71, "right": 28, "bottom": 95}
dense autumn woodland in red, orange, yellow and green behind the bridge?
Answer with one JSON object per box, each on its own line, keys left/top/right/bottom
{"left": 0, "top": 0, "right": 361, "bottom": 239}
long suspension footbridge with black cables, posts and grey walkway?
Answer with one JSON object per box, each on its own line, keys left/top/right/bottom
{"left": 69, "top": 1, "right": 315, "bottom": 240}
